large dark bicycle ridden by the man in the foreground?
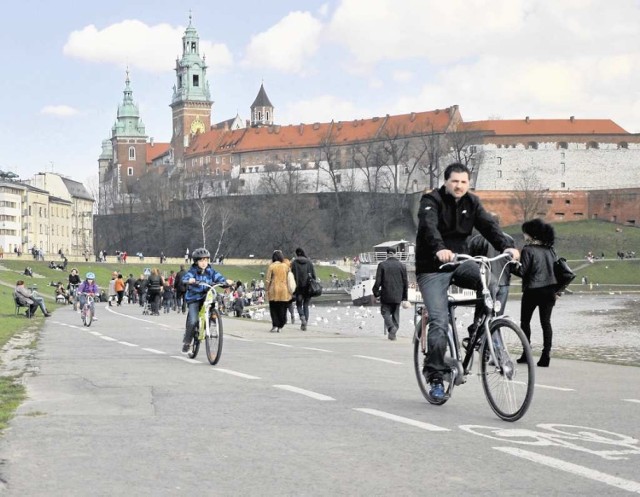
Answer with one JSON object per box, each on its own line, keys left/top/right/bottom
{"left": 413, "top": 254, "right": 535, "bottom": 421}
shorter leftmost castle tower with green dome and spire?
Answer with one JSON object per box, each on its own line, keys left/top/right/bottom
{"left": 112, "top": 69, "right": 147, "bottom": 188}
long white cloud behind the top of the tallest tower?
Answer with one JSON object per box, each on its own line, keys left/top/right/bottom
{"left": 63, "top": 19, "right": 233, "bottom": 72}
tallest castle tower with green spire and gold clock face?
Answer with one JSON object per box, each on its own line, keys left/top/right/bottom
{"left": 171, "top": 14, "right": 213, "bottom": 167}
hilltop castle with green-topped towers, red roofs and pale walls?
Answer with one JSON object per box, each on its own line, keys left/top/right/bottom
{"left": 98, "top": 17, "right": 640, "bottom": 225}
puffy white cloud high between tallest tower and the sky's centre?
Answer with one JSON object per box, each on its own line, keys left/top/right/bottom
{"left": 244, "top": 12, "right": 323, "bottom": 74}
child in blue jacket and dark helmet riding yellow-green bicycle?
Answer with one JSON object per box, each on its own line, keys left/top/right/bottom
{"left": 182, "top": 248, "right": 233, "bottom": 354}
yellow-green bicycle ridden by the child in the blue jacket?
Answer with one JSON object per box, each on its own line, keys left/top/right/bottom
{"left": 187, "top": 282, "right": 228, "bottom": 366}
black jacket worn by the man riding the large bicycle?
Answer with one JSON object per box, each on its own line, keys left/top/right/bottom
{"left": 416, "top": 186, "right": 514, "bottom": 274}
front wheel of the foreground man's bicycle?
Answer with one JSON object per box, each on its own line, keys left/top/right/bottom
{"left": 480, "top": 318, "right": 535, "bottom": 421}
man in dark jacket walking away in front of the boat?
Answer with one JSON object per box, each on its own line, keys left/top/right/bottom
{"left": 373, "top": 247, "right": 409, "bottom": 340}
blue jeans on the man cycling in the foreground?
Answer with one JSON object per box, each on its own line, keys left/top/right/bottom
{"left": 417, "top": 261, "right": 482, "bottom": 381}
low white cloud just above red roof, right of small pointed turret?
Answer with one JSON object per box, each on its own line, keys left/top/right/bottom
{"left": 278, "top": 95, "right": 362, "bottom": 125}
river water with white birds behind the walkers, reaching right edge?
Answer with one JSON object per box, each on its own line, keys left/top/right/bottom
{"left": 256, "top": 294, "right": 640, "bottom": 366}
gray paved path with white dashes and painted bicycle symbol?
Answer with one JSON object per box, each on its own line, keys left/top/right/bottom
{"left": 0, "top": 305, "right": 640, "bottom": 496}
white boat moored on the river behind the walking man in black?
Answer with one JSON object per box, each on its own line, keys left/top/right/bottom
{"left": 350, "top": 240, "right": 475, "bottom": 306}
